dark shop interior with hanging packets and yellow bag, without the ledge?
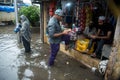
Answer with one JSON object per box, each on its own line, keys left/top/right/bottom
{"left": 53, "top": 0, "right": 116, "bottom": 59}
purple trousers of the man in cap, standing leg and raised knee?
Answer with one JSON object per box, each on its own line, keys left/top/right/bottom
{"left": 48, "top": 35, "right": 70, "bottom": 66}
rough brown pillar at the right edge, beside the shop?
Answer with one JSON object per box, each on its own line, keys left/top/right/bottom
{"left": 105, "top": 16, "right": 120, "bottom": 80}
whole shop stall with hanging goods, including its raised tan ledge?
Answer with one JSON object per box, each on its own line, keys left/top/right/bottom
{"left": 39, "top": 0, "right": 117, "bottom": 79}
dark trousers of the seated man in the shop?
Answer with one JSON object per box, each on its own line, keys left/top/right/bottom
{"left": 88, "top": 39, "right": 105, "bottom": 55}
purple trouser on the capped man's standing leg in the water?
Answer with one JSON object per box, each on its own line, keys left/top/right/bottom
{"left": 48, "top": 44, "right": 60, "bottom": 66}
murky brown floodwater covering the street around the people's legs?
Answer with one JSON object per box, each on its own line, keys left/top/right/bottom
{"left": 0, "top": 26, "right": 103, "bottom": 80}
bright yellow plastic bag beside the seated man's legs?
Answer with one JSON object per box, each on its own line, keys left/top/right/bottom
{"left": 75, "top": 39, "right": 94, "bottom": 54}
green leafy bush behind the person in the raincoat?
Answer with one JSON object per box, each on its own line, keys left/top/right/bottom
{"left": 19, "top": 6, "right": 40, "bottom": 26}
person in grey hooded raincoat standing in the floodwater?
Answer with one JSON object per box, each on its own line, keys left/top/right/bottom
{"left": 20, "top": 15, "right": 31, "bottom": 53}
